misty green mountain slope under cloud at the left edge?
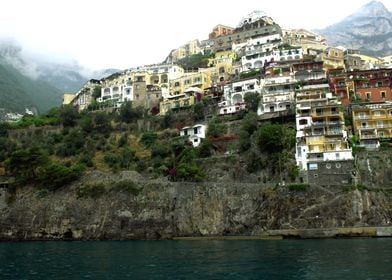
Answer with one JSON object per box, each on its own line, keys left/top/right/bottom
{"left": 0, "top": 38, "right": 118, "bottom": 113}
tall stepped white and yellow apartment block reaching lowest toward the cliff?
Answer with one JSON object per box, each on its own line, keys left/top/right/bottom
{"left": 294, "top": 62, "right": 353, "bottom": 171}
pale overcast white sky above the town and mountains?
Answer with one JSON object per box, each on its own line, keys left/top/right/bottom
{"left": 0, "top": 0, "right": 392, "bottom": 69}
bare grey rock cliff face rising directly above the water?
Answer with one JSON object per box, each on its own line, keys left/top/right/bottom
{"left": 0, "top": 172, "right": 392, "bottom": 240}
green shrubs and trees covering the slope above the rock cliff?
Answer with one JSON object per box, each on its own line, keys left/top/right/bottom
{"left": 0, "top": 102, "right": 297, "bottom": 191}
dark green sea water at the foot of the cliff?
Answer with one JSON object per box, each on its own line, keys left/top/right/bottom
{"left": 0, "top": 239, "right": 392, "bottom": 280}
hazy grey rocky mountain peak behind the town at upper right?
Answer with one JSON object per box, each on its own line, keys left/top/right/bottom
{"left": 316, "top": 1, "right": 392, "bottom": 56}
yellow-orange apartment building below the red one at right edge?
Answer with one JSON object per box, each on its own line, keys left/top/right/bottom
{"left": 352, "top": 102, "right": 392, "bottom": 149}
